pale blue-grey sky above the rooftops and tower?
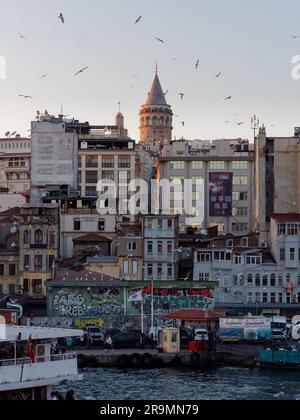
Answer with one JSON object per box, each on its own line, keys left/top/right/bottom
{"left": 0, "top": 0, "right": 300, "bottom": 140}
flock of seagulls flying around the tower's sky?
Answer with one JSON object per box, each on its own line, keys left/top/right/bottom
{"left": 14, "top": 13, "right": 300, "bottom": 131}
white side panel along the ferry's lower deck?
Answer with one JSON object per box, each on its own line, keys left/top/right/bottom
{"left": 0, "top": 353, "right": 81, "bottom": 392}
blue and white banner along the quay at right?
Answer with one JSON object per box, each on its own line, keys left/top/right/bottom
{"left": 220, "top": 318, "right": 272, "bottom": 341}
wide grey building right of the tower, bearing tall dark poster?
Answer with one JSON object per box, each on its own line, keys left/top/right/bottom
{"left": 159, "top": 140, "right": 254, "bottom": 235}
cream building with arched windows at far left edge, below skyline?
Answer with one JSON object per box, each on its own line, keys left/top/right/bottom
{"left": 0, "top": 137, "right": 31, "bottom": 194}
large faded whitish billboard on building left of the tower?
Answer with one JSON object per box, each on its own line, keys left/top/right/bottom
{"left": 31, "top": 132, "right": 78, "bottom": 188}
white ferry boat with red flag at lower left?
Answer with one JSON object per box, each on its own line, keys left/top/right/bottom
{"left": 0, "top": 325, "right": 83, "bottom": 401}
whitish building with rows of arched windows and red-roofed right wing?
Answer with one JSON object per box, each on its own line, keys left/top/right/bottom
{"left": 194, "top": 215, "right": 300, "bottom": 314}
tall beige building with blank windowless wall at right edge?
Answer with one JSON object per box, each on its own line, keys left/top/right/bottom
{"left": 255, "top": 127, "right": 300, "bottom": 243}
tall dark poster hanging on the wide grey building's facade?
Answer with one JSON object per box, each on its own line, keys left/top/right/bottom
{"left": 209, "top": 172, "right": 233, "bottom": 217}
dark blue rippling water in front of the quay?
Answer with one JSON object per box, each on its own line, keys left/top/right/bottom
{"left": 58, "top": 368, "right": 300, "bottom": 401}
